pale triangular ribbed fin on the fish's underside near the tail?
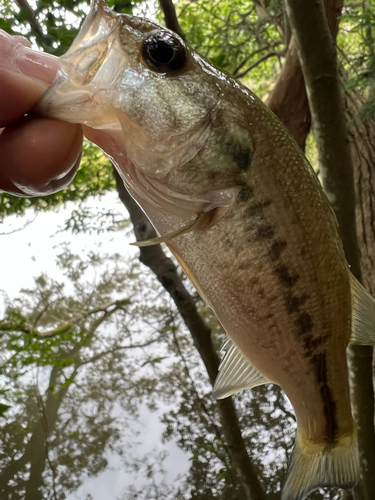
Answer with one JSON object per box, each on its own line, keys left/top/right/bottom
{"left": 212, "top": 338, "right": 270, "bottom": 399}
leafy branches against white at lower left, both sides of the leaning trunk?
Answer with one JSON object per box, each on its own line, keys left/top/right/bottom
{"left": 0, "top": 247, "right": 302, "bottom": 500}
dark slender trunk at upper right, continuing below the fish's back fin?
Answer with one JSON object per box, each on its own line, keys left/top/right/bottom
{"left": 286, "top": 0, "right": 375, "bottom": 500}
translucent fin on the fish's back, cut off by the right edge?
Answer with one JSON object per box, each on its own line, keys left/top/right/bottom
{"left": 349, "top": 275, "right": 375, "bottom": 345}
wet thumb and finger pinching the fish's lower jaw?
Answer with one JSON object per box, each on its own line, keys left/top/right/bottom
{"left": 0, "top": 30, "right": 82, "bottom": 196}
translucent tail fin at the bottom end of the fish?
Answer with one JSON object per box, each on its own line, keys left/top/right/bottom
{"left": 281, "top": 435, "right": 359, "bottom": 500}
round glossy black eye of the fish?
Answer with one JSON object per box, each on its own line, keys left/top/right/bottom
{"left": 142, "top": 33, "right": 187, "bottom": 73}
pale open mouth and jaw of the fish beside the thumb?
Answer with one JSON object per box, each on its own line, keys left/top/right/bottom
{"left": 33, "top": 0, "right": 137, "bottom": 129}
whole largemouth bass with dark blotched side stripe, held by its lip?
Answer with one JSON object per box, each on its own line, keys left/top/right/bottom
{"left": 36, "top": 0, "right": 375, "bottom": 500}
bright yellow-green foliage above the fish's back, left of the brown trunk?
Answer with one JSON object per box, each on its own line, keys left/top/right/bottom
{"left": 176, "top": 0, "right": 285, "bottom": 94}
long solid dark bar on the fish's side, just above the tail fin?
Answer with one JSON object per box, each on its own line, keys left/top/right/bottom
{"left": 311, "top": 352, "right": 339, "bottom": 445}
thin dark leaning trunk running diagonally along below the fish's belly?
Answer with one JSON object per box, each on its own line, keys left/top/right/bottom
{"left": 114, "top": 169, "right": 266, "bottom": 500}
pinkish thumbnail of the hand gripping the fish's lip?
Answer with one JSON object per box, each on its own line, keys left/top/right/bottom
{"left": 13, "top": 44, "right": 59, "bottom": 83}
